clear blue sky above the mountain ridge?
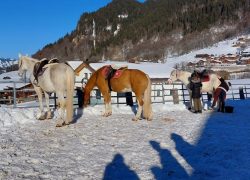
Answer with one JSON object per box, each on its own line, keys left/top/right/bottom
{"left": 0, "top": 0, "right": 143, "bottom": 58}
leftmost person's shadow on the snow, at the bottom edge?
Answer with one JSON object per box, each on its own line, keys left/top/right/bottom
{"left": 103, "top": 154, "right": 139, "bottom": 180}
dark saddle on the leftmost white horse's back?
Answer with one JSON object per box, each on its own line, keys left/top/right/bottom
{"left": 33, "top": 58, "right": 59, "bottom": 85}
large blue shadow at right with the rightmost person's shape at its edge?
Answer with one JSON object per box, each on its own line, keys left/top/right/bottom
{"left": 170, "top": 100, "right": 250, "bottom": 179}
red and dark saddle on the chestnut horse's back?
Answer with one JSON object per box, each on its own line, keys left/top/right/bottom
{"left": 102, "top": 65, "right": 128, "bottom": 91}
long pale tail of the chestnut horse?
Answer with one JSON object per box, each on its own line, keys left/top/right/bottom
{"left": 142, "top": 75, "right": 153, "bottom": 120}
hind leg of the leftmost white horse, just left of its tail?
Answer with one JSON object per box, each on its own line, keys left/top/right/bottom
{"left": 56, "top": 93, "right": 66, "bottom": 127}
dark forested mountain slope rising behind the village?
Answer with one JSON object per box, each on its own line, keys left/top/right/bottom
{"left": 34, "top": 0, "right": 250, "bottom": 61}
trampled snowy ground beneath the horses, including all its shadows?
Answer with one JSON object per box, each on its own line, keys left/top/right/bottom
{"left": 0, "top": 99, "right": 250, "bottom": 180}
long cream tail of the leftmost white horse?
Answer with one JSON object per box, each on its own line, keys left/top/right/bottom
{"left": 66, "top": 68, "right": 75, "bottom": 123}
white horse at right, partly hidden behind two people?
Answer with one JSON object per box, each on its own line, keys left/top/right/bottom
{"left": 169, "top": 69, "right": 221, "bottom": 108}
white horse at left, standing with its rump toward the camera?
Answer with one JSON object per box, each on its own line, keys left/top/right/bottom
{"left": 18, "top": 55, "right": 75, "bottom": 127}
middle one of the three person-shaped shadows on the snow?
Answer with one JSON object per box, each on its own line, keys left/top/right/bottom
{"left": 149, "top": 141, "right": 189, "bottom": 180}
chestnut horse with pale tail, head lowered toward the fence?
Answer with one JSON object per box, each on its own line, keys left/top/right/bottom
{"left": 84, "top": 66, "right": 153, "bottom": 121}
